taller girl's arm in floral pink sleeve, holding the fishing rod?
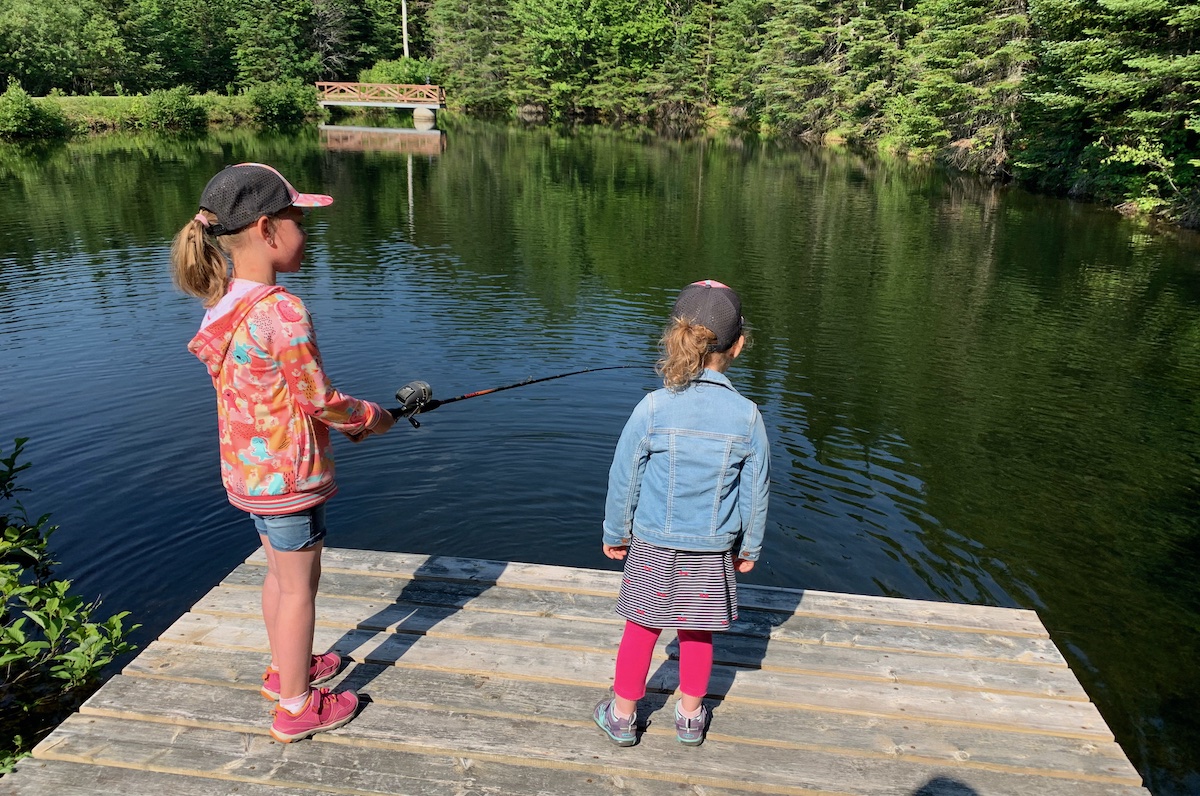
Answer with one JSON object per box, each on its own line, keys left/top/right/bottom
{"left": 266, "top": 293, "right": 390, "bottom": 435}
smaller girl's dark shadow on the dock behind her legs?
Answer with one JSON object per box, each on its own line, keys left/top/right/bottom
{"left": 638, "top": 585, "right": 804, "bottom": 723}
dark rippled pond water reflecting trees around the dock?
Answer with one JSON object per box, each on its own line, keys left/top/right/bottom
{"left": 0, "top": 126, "right": 1200, "bottom": 794}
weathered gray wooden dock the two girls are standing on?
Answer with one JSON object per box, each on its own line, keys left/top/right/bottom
{"left": 0, "top": 545, "right": 1148, "bottom": 796}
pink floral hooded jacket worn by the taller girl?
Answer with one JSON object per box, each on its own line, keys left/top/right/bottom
{"left": 187, "top": 280, "right": 384, "bottom": 515}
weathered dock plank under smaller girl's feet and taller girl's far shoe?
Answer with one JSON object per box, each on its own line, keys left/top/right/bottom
{"left": 121, "top": 641, "right": 1140, "bottom": 784}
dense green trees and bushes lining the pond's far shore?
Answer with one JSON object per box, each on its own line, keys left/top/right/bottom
{"left": 0, "top": 0, "right": 1200, "bottom": 220}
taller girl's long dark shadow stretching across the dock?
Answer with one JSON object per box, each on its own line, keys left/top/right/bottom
{"left": 331, "top": 556, "right": 506, "bottom": 701}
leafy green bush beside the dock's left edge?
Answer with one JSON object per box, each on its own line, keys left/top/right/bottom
{"left": 0, "top": 438, "right": 138, "bottom": 773}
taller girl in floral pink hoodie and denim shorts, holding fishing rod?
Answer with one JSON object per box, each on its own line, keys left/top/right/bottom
{"left": 172, "top": 163, "right": 394, "bottom": 743}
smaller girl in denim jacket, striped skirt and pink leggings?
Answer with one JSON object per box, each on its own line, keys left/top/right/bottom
{"left": 593, "top": 280, "right": 770, "bottom": 747}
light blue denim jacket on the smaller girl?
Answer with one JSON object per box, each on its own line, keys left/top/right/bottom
{"left": 604, "top": 370, "right": 770, "bottom": 561}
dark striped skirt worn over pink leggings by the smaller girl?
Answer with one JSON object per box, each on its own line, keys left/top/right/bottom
{"left": 617, "top": 537, "right": 738, "bottom": 630}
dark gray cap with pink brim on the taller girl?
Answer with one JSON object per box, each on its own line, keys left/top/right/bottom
{"left": 200, "top": 163, "right": 334, "bottom": 235}
